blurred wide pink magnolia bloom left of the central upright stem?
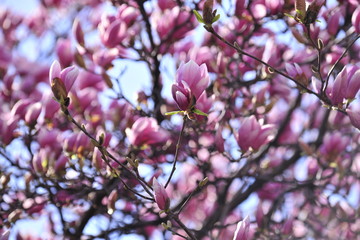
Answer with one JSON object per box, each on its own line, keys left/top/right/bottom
{"left": 125, "top": 117, "right": 169, "bottom": 147}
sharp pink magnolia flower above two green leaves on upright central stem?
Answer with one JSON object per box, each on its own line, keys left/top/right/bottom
{"left": 172, "top": 60, "right": 210, "bottom": 111}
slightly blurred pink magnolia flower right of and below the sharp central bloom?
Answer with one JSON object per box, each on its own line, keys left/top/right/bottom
{"left": 236, "top": 116, "right": 274, "bottom": 152}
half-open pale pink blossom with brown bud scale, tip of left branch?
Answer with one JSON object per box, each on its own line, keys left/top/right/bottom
{"left": 49, "top": 61, "right": 79, "bottom": 100}
